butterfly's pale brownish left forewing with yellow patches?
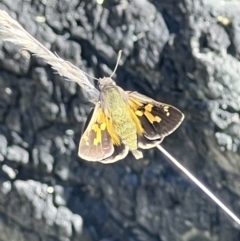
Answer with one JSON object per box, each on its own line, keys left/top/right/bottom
{"left": 78, "top": 102, "right": 114, "bottom": 161}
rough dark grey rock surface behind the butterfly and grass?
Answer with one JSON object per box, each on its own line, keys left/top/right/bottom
{"left": 0, "top": 0, "right": 240, "bottom": 241}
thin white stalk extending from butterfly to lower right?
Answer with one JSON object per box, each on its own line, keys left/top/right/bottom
{"left": 157, "top": 145, "right": 240, "bottom": 225}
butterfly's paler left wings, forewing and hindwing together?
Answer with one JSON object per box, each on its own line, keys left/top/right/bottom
{"left": 78, "top": 102, "right": 129, "bottom": 164}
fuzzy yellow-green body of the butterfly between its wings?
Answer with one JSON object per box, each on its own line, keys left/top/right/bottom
{"left": 100, "top": 79, "right": 137, "bottom": 150}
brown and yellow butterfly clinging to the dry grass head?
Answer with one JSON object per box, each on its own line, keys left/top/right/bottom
{"left": 78, "top": 77, "right": 184, "bottom": 164}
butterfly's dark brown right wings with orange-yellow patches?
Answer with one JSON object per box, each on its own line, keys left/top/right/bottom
{"left": 127, "top": 92, "right": 184, "bottom": 149}
